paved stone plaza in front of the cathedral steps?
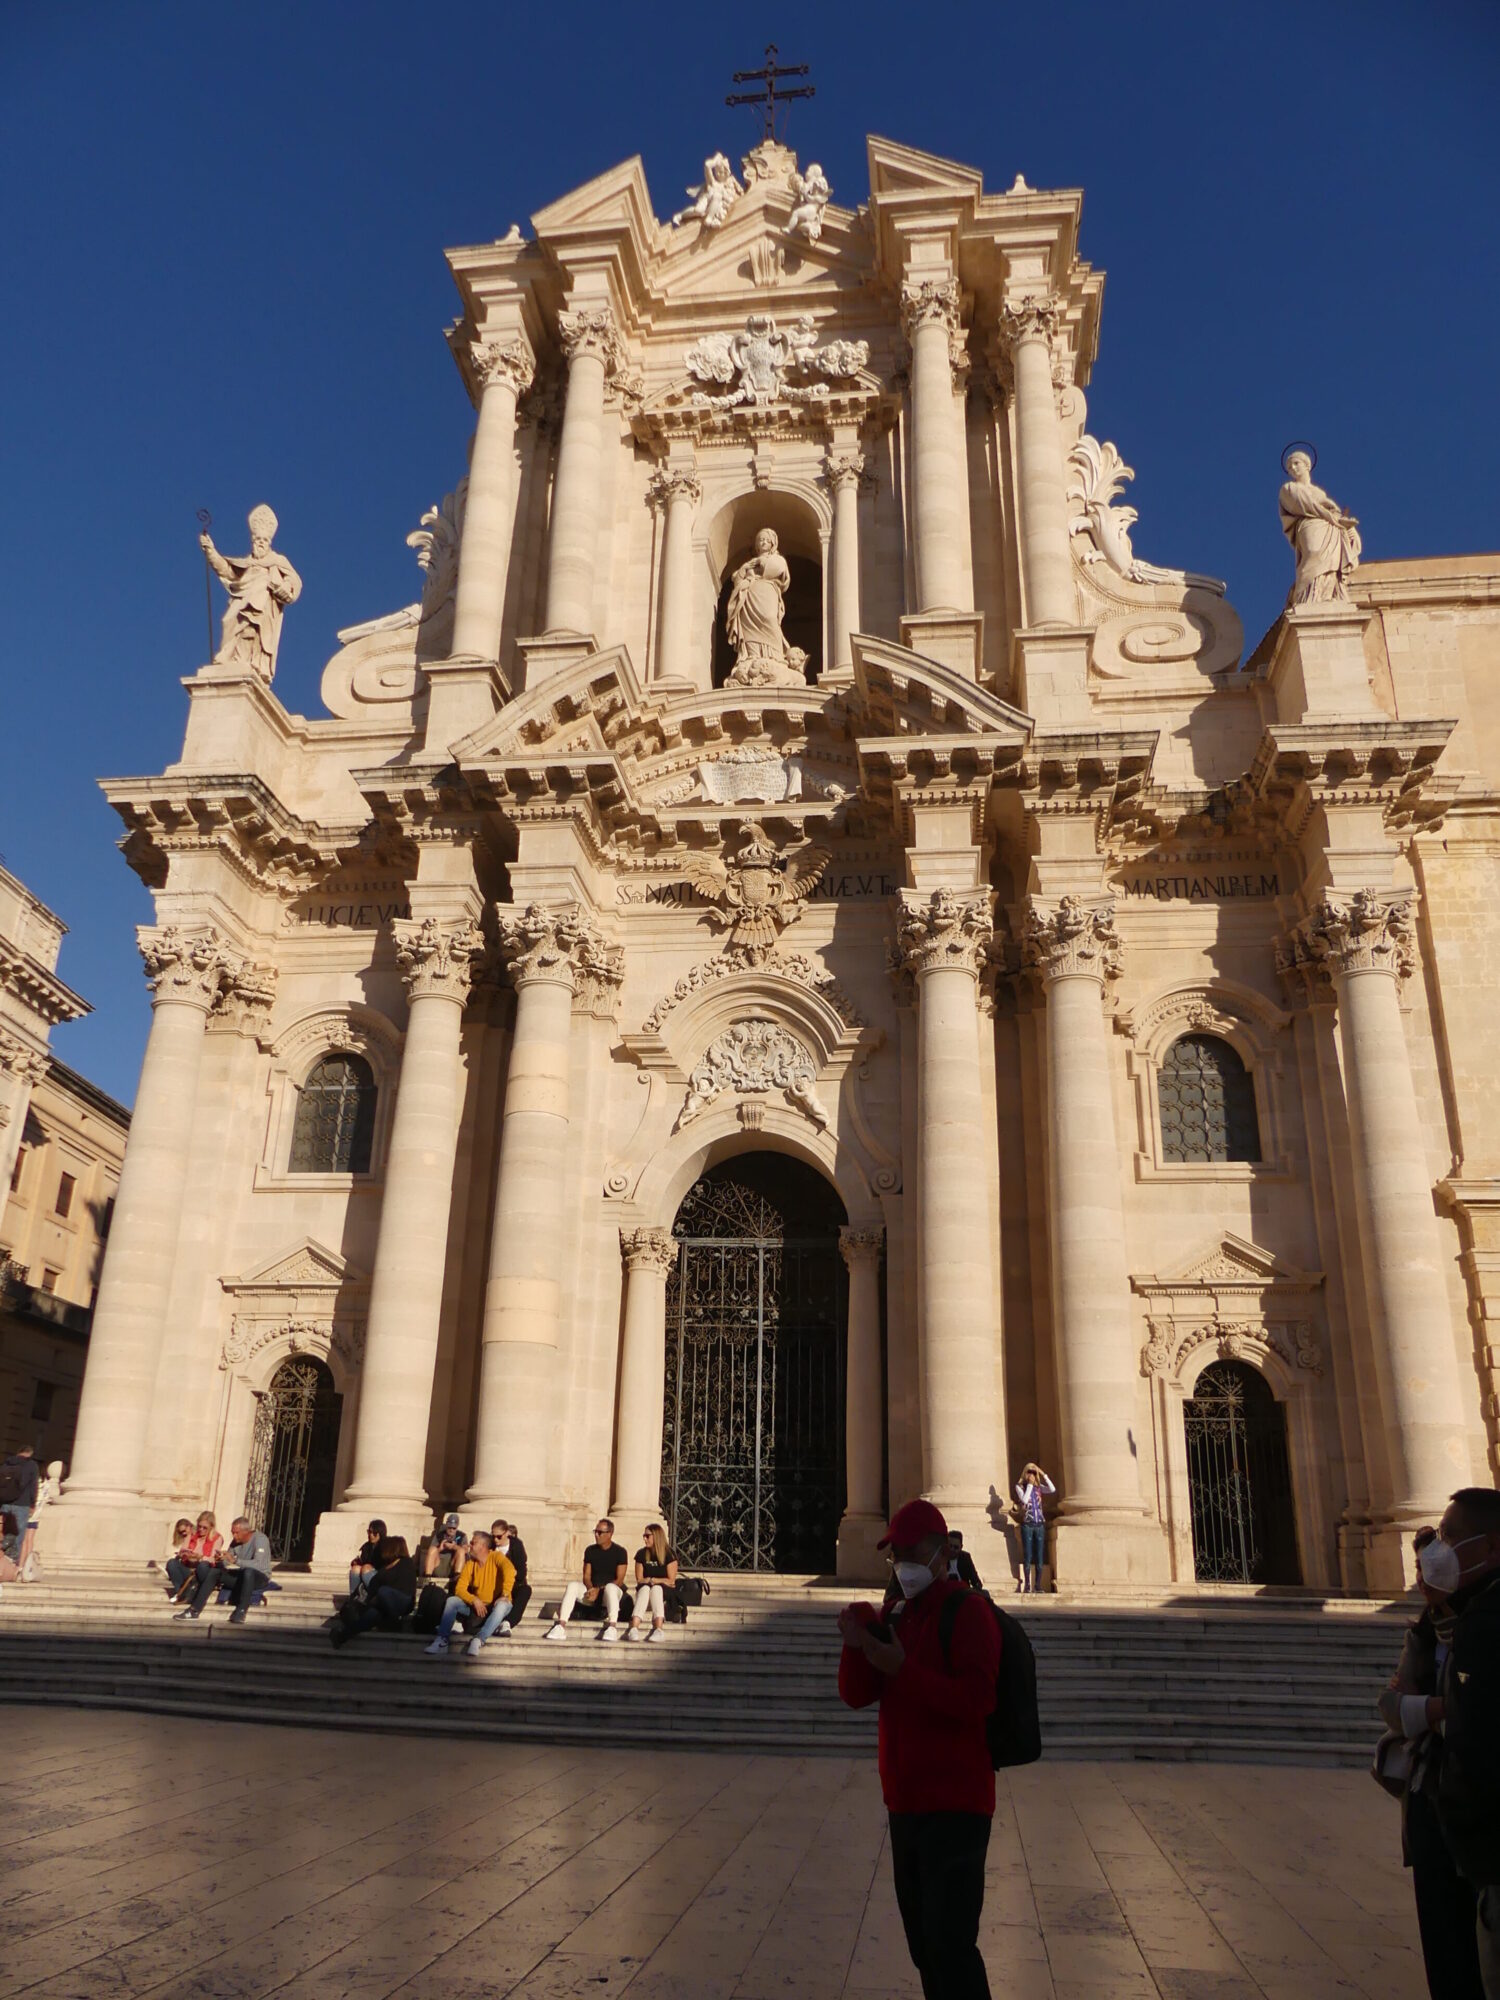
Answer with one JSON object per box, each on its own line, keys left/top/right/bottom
{"left": 0, "top": 1708, "right": 1424, "bottom": 2000}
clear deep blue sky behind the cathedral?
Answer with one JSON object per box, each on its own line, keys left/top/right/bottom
{"left": 0, "top": 0, "right": 1500, "bottom": 1102}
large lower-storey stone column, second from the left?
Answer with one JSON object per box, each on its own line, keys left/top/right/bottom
{"left": 340, "top": 916, "right": 484, "bottom": 1512}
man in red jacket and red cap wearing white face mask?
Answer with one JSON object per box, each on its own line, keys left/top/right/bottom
{"left": 838, "top": 1500, "right": 1000, "bottom": 2000}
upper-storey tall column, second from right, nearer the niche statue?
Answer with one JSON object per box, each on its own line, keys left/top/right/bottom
{"left": 902, "top": 278, "right": 974, "bottom": 612}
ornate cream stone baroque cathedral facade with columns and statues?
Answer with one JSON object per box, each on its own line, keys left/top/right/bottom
{"left": 52, "top": 140, "right": 1500, "bottom": 1592}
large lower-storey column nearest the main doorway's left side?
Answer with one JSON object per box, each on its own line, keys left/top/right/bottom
{"left": 468, "top": 902, "right": 622, "bottom": 1518}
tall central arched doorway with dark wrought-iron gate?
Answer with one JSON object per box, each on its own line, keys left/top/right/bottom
{"left": 662, "top": 1154, "right": 848, "bottom": 1574}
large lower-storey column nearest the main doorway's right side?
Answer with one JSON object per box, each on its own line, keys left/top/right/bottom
{"left": 898, "top": 890, "right": 1004, "bottom": 1532}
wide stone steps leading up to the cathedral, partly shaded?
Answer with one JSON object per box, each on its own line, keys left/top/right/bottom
{"left": 0, "top": 1574, "right": 1404, "bottom": 1764}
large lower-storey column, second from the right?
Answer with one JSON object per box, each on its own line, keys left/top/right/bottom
{"left": 1026, "top": 896, "right": 1166, "bottom": 1582}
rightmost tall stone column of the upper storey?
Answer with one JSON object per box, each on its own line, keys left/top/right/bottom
{"left": 1000, "top": 298, "right": 1078, "bottom": 626}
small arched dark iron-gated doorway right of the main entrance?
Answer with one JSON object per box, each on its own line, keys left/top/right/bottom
{"left": 1182, "top": 1362, "right": 1300, "bottom": 1584}
